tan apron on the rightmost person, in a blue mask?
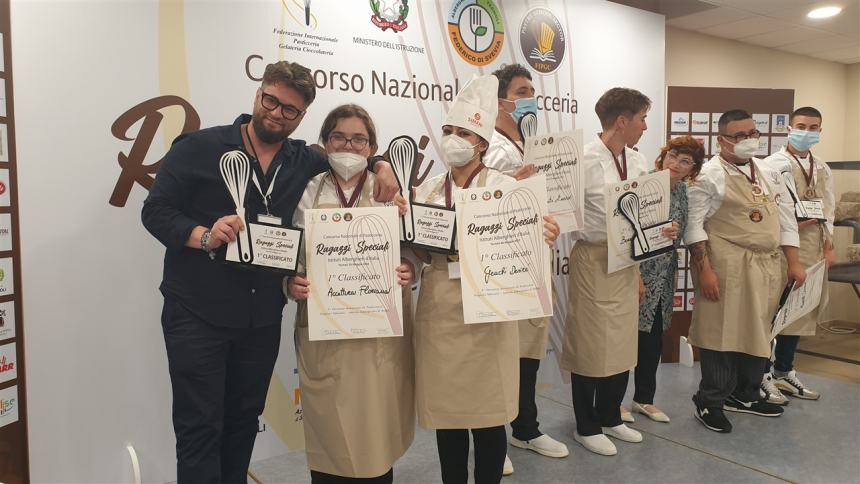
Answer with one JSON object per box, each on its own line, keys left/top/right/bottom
{"left": 780, "top": 163, "right": 833, "bottom": 336}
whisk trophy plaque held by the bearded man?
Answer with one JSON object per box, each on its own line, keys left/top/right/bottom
{"left": 219, "top": 150, "right": 302, "bottom": 274}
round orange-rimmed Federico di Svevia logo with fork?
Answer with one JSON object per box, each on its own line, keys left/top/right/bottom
{"left": 448, "top": 0, "right": 505, "bottom": 66}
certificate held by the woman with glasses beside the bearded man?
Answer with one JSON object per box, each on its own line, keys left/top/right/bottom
{"left": 305, "top": 207, "right": 403, "bottom": 341}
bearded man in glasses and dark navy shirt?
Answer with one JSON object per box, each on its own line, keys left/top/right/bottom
{"left": 142, "top": 61, "right": 398, "bottom": 483}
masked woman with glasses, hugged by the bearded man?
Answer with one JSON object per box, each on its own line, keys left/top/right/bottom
{"left": 284, "top": 104, "right": 415, "bottom": 484}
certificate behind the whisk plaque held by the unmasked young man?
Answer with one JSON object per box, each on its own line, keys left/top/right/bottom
{"left": 605, "top": 170, "right": 674, "bottom": 274}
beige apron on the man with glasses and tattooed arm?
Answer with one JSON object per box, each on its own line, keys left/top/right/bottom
{"left": 689, "top": 161, "right": 785, "bottom": 358}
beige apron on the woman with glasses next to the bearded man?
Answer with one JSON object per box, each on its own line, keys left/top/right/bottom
{"left": 295, "top": 174, "right": 415, "bottom": 478}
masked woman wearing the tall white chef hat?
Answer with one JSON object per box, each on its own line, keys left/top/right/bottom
{"left": 404, "top": 76, "right": 559, "bottom": 484}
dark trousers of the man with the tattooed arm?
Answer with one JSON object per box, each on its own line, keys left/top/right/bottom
{"left": 695, "top": 348, "right": 767, "bottom": 408}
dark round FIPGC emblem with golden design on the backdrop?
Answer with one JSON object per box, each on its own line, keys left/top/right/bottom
{"left": 520, "top": 7, "right": 567, "bottom": 74}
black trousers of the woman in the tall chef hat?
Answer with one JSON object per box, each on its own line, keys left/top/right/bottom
{"left": 436, "top": 425, "right": 508, "bottom": 484}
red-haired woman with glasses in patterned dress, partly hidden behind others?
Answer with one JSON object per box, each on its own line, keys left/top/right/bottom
{"left": 633, "top": 136, "right": 705, "bottom": 422}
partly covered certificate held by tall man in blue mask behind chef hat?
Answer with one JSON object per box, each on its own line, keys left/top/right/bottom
{"left": 523, "top": 129, "right": 585, "bottom": 234}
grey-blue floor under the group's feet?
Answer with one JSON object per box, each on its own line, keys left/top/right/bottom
{"left": 249, "top": 360, "right": 860, "bottom": 484}
